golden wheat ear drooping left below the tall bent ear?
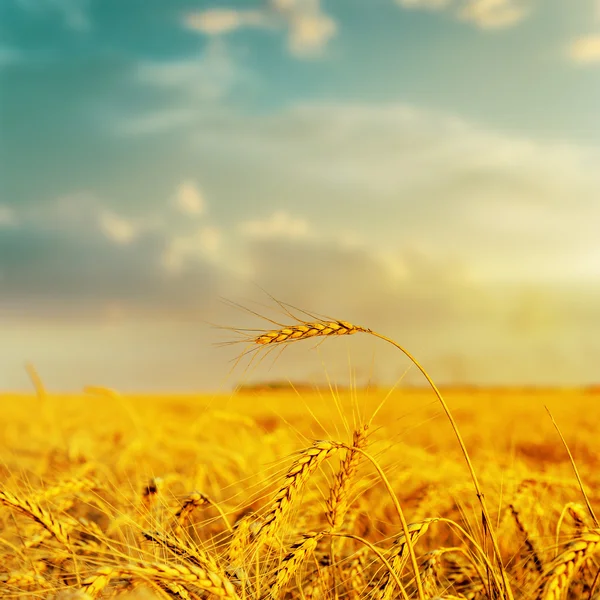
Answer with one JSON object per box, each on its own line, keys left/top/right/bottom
{"left": 256, "top": 440, "right": 338, "bottom": 544}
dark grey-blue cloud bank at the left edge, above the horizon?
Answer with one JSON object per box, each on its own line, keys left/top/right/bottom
{"left": 0, "top": 201, "right": 220, "bottom": 318}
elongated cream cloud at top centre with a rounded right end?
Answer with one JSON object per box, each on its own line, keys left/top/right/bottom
{"left": 184, "top": 0, "right": 337, "bottom": 58}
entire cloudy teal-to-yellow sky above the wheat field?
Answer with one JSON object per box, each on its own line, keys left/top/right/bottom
{"left": 0, "top": 0, "right": 600, "bottom": 391}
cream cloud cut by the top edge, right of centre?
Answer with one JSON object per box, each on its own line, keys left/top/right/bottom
{"left": 396, "top": 0, "right": 532, "bottom": 29}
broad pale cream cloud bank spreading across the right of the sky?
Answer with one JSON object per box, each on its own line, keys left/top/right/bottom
{"left": 182, "top": 104, "right": 600, "bottom": 281}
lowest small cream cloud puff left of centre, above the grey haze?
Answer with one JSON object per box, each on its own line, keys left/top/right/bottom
{"left": 161, "top": 226, "right": 223, "bottom": 273}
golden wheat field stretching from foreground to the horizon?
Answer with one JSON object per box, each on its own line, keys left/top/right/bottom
{"left": 0, "top": 360, "right": 600, "bottom": 600}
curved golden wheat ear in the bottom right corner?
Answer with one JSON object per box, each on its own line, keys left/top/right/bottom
{"left": 537, "top": 529, "right": 600, "bottom": 600}
